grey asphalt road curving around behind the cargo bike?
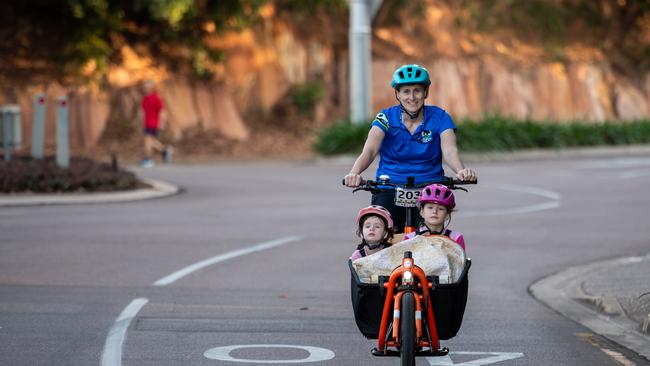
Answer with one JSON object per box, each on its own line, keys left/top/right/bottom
{"left": 0, "top": 156, "right": 650, "bottom": 366}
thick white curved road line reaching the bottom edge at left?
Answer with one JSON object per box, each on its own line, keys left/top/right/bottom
{"left": 101, "top": 298, "right": 149, "bottom": 366}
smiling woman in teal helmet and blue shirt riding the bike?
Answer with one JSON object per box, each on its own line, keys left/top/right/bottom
{"left": 344, "top": 64, "right": 477, "bottom": 233}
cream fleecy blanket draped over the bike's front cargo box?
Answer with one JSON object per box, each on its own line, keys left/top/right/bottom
{"left": 352, "top": 235, "right": 465, "bottom": 283}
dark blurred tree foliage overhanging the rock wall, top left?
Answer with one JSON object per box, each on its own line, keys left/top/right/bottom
{"left": 0, "top": 0, "right": 344, "bottom": 81}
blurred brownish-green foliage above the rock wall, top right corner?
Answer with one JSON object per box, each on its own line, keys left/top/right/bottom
{"left": 447, "top": 0, "right": 650, "bottom": 70}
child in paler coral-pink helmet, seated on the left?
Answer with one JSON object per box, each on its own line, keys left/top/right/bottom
{"left": 350, "top": 205, "right": 394, "bottom": 261}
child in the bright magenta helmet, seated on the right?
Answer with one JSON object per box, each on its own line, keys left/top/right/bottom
{"left": 404, "top": 183, "right": 465, "bottom": 250}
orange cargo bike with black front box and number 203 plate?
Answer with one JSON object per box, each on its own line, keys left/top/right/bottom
{"left": 348, "top": 177, "right": 476, "bottom": 366}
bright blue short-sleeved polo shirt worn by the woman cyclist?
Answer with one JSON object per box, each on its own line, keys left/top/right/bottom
{"left": 372, "top": 105, "right": 456, "bottom": 184}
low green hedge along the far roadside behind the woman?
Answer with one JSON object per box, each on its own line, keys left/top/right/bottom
{"left": 314, "top": 116, "right": 650, "bottom": 155}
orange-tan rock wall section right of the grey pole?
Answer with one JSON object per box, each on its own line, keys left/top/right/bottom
{"left": 373, "top": 59, "right": 650, "bottom": 122}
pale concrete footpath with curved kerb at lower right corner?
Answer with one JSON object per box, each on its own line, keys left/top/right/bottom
{"left": 529, "top": 253, "right": 650, "bottom": 360}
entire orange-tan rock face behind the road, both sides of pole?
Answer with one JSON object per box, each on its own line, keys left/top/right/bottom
{"left": 0, "top": 2, "right": 650, "bottom": 148}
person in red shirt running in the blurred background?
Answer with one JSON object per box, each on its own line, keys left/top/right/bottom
{"left": 141, "top": 80, "right": 171, "bottom": 167}
